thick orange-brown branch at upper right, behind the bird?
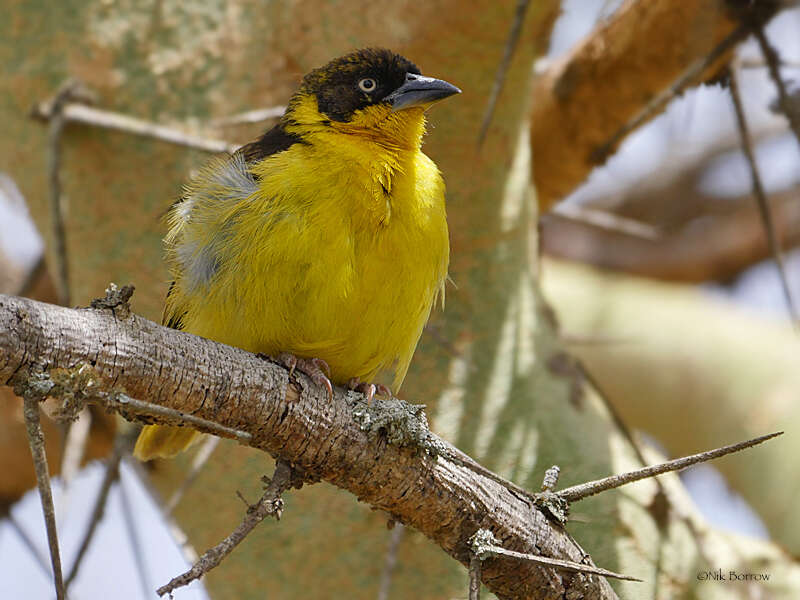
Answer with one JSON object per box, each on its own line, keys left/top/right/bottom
{"left": 531, "top": 0, "right": 780, "bottom": 211}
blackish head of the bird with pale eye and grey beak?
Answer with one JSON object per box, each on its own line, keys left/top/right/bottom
{"left": 290, "top": 48, "right": 460, "bottom": 123}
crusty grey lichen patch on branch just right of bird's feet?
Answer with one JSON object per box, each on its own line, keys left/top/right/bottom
{"left": 353, "top": 398, "right": 440, "bottom": 456}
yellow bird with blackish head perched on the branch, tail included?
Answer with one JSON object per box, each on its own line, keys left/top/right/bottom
{"left": 135, "top": 48, "right": 460, "bottom": 460}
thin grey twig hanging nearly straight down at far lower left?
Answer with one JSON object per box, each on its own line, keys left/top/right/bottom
{"left": 24, "top": 395, "right": 66, "bottom": 600}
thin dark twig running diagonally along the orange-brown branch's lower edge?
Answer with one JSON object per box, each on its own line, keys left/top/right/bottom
{"left": 590, "top": 25, "right": 750, "bottom": 164}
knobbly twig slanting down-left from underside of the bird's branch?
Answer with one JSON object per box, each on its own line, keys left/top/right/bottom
{"left": 156, "top": 460, "right": 296, "bottom": 596}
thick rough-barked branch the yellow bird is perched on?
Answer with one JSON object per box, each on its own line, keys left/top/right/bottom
{"left": 0, "top": 296, "right": 615, "bottom": 598}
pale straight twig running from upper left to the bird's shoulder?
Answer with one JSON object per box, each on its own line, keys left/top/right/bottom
{"left": 33, "top": 102, "right": 239, "bottom": 154}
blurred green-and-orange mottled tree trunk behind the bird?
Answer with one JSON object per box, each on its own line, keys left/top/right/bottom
{"left": 6, "top": 0, "right": 792, "bottom": 600}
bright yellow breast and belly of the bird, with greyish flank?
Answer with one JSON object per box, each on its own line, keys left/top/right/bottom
{"left": 167, "top": 129, "right": 449, "bottom": 391}
